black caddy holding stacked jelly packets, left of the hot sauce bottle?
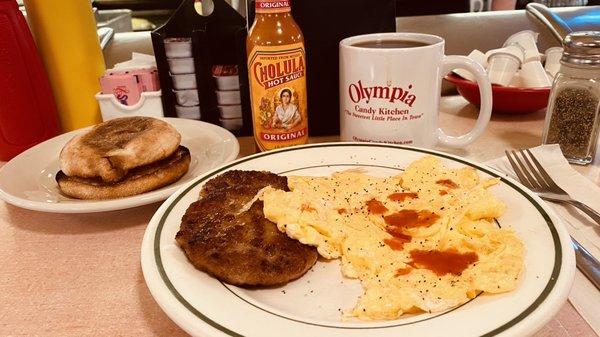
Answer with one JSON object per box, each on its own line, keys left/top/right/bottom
{"left": 151, "top": 0, "right": 252, "bottom": 136}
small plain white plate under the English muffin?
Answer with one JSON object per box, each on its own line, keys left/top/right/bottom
{"left": 0, "top": 118, "right": 240, "bottom": 213}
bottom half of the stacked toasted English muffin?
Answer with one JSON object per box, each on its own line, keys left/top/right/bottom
{"left": 56, "top": 146, "right": 191, "bottom": 200}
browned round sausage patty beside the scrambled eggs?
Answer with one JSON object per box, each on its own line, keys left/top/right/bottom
{"left": 175, "top": 171, "right": 317, "bottom": 286}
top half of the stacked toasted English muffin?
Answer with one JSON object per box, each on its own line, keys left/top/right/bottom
{"left": 60, "top": 116, "right": 181, "bottom": 182}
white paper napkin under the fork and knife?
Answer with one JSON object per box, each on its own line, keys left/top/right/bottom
{"left": 487, "top": 145, "right": 600, "bottom": 335}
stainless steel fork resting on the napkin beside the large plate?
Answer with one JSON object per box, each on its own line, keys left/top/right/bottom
{"left": 505, "top": 149, "right": 600, "bottom": 225}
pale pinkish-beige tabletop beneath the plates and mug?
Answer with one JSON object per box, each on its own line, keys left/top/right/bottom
{"left": 0, "top": 96, "right": 600, "bottom": 337}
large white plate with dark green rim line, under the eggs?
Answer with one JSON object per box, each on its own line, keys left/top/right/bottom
{"left": 141, "top": 143, "right": 575, "bottom": 337}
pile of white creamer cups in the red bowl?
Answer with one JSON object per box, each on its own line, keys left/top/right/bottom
{"left": 454, "top": 30, "right": 563, "bottom": 88}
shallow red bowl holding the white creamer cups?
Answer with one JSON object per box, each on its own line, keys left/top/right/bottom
{"left": 444, "top": 73, "right": 550, "bottom": 114}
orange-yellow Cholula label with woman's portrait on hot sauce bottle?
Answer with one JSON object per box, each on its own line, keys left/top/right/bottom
{"left": 248, "top": 43, "right": 308, "bottom": 151}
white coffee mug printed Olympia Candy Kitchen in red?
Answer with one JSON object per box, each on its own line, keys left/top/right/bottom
{"left": 340, "top": 33, "right": 492, "bottom": 147}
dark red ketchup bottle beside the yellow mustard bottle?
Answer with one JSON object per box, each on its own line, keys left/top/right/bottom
{"left": 0, "top": 0, "right": 60, "bottom": 161}
